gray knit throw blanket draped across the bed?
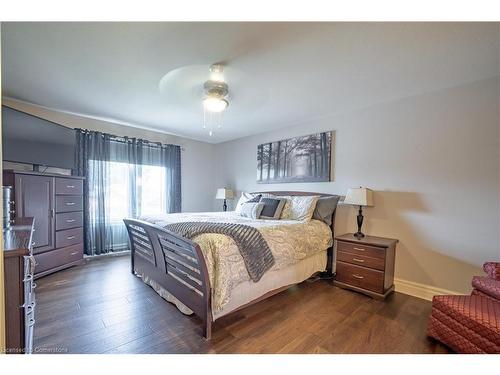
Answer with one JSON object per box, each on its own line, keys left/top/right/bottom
{"left": 165, "top": 221, "right": 274, "bottom": 282}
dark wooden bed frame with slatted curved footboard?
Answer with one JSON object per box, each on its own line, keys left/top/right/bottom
{"left": 123, "top": 191, "right": 335, "bottom": 340}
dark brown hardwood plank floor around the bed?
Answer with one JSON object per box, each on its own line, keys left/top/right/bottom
{"left": 35, "top": 256, "right": 448, "bottom": 353}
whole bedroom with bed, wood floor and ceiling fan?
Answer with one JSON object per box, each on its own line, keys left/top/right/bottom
{"left": 1, "top": 0, "right": 500, "bottom": 374}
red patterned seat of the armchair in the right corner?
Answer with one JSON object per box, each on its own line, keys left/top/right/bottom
{"left": 432, "top": 295, "right": 500, "bottom": 348}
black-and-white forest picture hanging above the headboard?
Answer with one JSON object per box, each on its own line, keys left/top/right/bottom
{"left": 257, "top": 132, "right": 332, "bottom": 184}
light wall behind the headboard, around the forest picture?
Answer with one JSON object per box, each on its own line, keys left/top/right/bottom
{"left": 214, "top": 78, "right": 500, "bottom": 292}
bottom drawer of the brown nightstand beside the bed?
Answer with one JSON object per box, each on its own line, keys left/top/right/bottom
{"left": 335, "top": 262, "right": 384, "bottom": 293}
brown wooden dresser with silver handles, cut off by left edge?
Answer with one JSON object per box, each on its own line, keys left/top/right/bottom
{"left": 3, "top": 218, "right": 36, "bottom": 354}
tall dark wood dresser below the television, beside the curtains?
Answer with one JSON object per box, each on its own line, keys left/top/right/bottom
{"left": 3, "top": 170, "right": 83, "bottom": 278}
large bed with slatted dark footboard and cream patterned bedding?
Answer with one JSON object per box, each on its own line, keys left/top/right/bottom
{"left": 124, "top": 191, "right": 335, "bottom": 339}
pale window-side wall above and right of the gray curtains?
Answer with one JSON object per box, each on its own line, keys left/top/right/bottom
{"left": 3, "top": 98, "right": 215, "bottom": 212}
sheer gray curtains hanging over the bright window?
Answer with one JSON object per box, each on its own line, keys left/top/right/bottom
{"left": 75, "top": 129, "right": 181, "bottom": 255}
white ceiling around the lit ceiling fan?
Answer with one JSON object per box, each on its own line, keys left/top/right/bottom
{"left": 2, "top": 23, "right": 500, "bottom": 143}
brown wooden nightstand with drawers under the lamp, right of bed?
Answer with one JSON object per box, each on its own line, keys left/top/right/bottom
{"left": 334, "top": 233, "right": 398, "bottom": 299}
